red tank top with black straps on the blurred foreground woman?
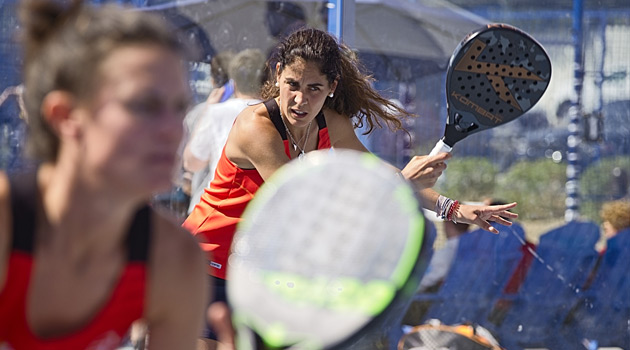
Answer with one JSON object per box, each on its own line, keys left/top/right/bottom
{"left": 0, "top": 174, "right": 151, "bottom": 350}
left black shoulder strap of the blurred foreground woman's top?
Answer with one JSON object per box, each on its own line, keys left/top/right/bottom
{"left": 9, "top": 171, "right": 39, "bottom": 253}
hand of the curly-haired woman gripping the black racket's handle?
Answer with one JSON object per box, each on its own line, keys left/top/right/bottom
{"left": 401, "top": 153, "right": 451, "bottom": 189}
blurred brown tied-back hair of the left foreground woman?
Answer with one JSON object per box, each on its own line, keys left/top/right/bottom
{"left": 19, "top": 0, "right": 187, "bottom": 160}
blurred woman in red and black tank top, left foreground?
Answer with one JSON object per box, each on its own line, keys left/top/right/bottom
{"left": 0, "top": 0, "right": 218, "bottom": 350}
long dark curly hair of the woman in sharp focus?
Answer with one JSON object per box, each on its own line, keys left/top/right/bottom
{"left": 262, "top": 28, "right": 412, "bottom": 134}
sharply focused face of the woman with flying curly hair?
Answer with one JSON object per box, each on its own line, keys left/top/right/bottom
{"left": 276, "top": 59, "right": 337, "bottom": 128}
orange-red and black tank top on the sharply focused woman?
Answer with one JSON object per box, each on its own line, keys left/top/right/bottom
{"left": 183, "top": 99, "right": 331, "bottom": 279}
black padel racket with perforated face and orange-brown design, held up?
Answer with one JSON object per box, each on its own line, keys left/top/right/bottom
{"left": 430, "top": 24, "right": 551, "bottom": 155}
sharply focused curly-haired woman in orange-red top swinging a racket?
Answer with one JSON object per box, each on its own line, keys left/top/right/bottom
{"left": 183, "top": 29, "right": 517, "bottom": 344}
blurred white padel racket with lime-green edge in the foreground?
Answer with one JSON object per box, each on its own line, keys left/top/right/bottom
{"left": 227, "top": 150, "right": 431, "bottom": 350}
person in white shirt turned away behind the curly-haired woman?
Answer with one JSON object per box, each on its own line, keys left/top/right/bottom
{"left": 183, "top": 49, "right": 265, "bottom": 213}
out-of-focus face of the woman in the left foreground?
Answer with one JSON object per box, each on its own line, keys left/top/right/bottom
{"left": 81, "top": 45, "right": 190, "bottom": 195}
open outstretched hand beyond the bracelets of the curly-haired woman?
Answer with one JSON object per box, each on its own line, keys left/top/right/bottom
{"left": 455, "top": 202, "right": 518, "bottom": 233}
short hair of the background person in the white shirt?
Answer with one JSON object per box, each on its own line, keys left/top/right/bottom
{"left": 229, "top": 49, "right": 265, "bottom": 96}
